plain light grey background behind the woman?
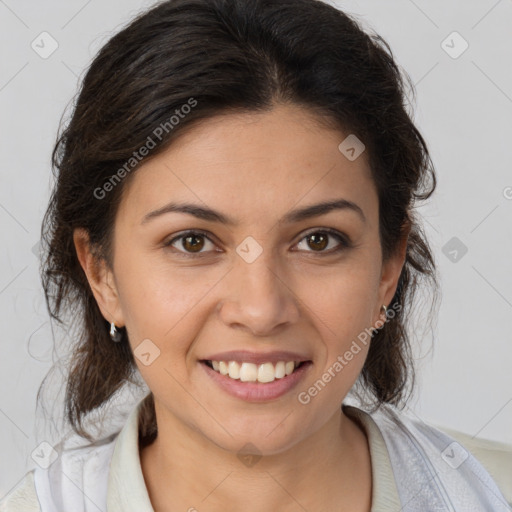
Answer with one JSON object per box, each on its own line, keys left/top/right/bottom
{"left": 0, "top": 0, "right": 512, "bottom": 498}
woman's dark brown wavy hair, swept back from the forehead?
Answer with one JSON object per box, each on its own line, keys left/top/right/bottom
{"left": 42, "top": 0, "right": 437, "bottom": 442}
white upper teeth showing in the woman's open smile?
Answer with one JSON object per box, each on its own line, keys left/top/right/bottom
{"left": 201, "top": 360, "right": 311, "bottom": 384}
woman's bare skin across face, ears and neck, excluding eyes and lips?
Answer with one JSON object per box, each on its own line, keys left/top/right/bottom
{"left": 75, "top": 105, "right": 406, "bottom": 512}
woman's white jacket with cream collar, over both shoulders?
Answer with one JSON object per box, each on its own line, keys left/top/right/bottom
{"left": 0, "top": 402, "right": 512, "bottom": 512}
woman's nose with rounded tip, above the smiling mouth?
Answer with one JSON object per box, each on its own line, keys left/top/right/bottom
{"left": 218, "top": 251, "right": 300, "bottom": 336}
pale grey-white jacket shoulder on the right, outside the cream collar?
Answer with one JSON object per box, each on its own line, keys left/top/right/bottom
{"left": 346, "top": 404, "right": 510, "bottom": 511}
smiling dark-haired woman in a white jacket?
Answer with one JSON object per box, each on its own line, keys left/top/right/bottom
{"left": 4, "top": 0, "right": 508, "bottom": 512}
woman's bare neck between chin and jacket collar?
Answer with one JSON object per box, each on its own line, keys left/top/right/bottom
{"left": 140, "top": 408, "right": 371, "bottom": 512}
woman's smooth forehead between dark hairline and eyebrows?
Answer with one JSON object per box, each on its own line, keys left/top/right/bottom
{"left": 119, "top": 106, "right": 377, "bottom": 227}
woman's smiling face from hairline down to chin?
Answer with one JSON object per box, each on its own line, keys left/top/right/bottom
{"left": 81, "top": 102, "right": 403, "bottom": 453}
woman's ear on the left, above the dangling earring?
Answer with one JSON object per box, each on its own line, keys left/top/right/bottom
{"left": 73, "top": 228, "right": 124, "bottom": 327}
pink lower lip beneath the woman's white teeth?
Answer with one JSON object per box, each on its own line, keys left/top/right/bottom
{"left": 199, "top": 361, "right": 311, "bottom": 402}
